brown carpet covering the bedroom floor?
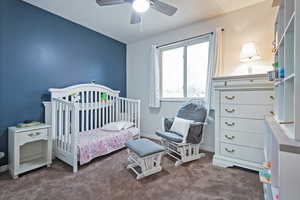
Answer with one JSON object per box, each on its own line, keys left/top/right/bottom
{"left": 0, "top": 150, "right": 263, "bottom": 200}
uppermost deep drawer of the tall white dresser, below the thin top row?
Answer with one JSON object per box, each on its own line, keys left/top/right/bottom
{"left": 221, "top": 90, "right": 274, "bottom": 105}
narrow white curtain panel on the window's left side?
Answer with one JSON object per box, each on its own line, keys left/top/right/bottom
{"left": 149, "top": 45, "right": 160, "bottom": 108}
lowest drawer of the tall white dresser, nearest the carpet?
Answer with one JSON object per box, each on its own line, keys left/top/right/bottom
{"left": 221, "top": 143, "right": 264, "bottom": 163}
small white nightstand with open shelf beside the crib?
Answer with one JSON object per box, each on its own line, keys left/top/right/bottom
{"left": 8, "top": 124, "right": 52, "bottom": 179}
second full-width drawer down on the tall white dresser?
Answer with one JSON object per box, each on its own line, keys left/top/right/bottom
{"left": 220, "top": 104, "right": 273, "bottom": 119}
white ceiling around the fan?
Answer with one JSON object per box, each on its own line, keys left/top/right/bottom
{"left": 23, "top": 0, "right": 265, "bottom": 43}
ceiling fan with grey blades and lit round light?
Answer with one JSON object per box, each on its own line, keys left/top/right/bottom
{"left": 96, "top": 0, "right": 177, "bottom": 24}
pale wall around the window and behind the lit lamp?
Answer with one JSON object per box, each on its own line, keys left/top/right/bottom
{"left": 127, "top": 1, "right": 276, "bottom": 150}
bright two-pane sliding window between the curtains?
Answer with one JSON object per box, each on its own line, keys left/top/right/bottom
{"left": 160, "top": 37, "right": 210, "bottom": 99}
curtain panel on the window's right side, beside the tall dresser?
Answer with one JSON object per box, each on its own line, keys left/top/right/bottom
{"left": 205, "top": 28, "right": 223, "bottom": 111}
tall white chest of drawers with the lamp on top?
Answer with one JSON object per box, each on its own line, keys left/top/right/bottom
{"left": 213, "top": 74, "right": 274, "bottom": 170}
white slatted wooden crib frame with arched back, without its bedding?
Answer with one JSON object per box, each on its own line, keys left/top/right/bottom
{"left": 44, "top": 84, "right": 140, "bottom": 172}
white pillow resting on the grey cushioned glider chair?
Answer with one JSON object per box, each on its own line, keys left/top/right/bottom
{"left": 170, "top": 117, "right": 193, "bottom": 143}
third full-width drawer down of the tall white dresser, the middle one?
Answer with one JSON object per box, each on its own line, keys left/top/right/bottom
{"left": 220, "top": 117, "right": 266, "bottom": 134}
